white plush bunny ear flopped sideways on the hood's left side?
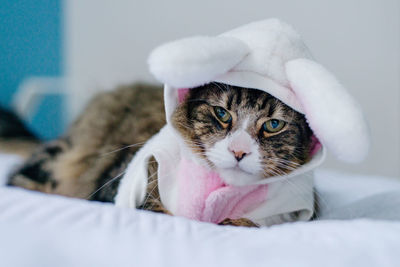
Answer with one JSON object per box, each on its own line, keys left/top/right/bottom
{"left": 148, "top": 36, "right": 249, "bottom": 88}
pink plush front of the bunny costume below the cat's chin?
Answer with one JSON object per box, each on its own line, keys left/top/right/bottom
{"left": 176, "top": 159, "right": 268, "bottom": 223}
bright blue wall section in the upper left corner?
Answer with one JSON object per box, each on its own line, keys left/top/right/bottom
{"left": 0, "top": 0, "right": 62, "bottom": 140}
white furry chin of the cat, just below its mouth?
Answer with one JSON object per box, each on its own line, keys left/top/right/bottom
{"left": 218, "top": 167, "right": 262, "bottom": 186}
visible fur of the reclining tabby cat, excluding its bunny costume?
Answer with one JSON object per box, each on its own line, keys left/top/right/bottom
{"left": 9, "top": 83, "right": 312, "bottom": 226}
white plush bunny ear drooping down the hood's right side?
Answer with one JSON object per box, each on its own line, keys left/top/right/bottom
{"left": 285, "top": 59, "right": 369, "bottom": 163}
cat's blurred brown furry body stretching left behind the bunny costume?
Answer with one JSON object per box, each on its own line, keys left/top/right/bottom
{"left": 10, "top": 84, "right": 165, "bottom": 201}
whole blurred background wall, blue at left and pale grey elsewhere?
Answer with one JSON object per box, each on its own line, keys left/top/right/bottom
{"left": 0, "top": 0, "right": 400, "bottom": 177}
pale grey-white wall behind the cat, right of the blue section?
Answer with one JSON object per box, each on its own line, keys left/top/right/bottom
{"left": 65, "top": 0, "right": 400, "bottom": 176}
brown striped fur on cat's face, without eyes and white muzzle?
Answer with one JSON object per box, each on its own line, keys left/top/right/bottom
{"left": 173, "top": 83, "right": 312, "bottom": 178}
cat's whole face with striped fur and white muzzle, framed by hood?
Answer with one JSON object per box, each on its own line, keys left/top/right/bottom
{"left": 172, "top": 83, "right": 312, "bottom": 185}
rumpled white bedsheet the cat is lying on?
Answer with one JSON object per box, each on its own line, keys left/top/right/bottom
{"left": 0, "top": 153, "right": 400, "bottom": 267}
